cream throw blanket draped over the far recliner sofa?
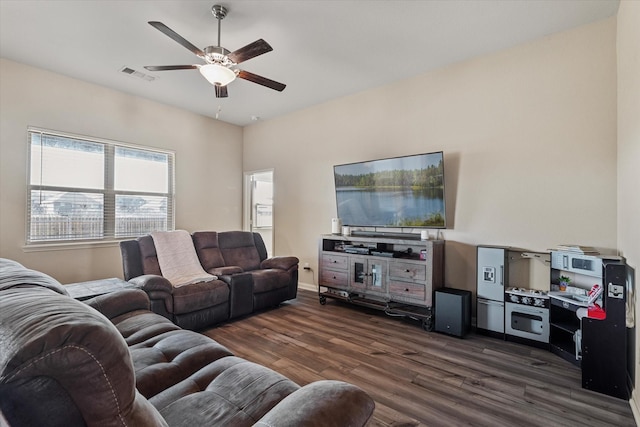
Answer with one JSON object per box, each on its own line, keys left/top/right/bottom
{"left": 151, "top": 230, "right": 217, "bottom": 287}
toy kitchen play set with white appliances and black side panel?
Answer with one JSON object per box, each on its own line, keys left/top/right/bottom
{"left": 476, "top": 245, "right": 632, "bottom": 399}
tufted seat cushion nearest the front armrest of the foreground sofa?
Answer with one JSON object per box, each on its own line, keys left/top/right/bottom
{"left": 150, "top": 356, "right": 300, "bottom": 426}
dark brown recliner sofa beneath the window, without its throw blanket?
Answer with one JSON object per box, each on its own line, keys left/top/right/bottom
{"left": 120, "top": 231, "right": 299, "bottom": 329}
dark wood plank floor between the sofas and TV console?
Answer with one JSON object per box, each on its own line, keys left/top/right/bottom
{"left": 205, "top": 290, "right": 635, "bottom": 427}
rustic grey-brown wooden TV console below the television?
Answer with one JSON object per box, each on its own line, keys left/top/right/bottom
{"left": 318, "top": 234, "right": 444, "bottom": 331}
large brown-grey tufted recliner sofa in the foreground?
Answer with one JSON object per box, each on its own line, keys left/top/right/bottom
{"left": 0, "top": 259, "right": 374, "bottom": 427}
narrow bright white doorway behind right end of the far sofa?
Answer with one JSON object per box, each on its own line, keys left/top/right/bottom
{"left": 244, "top": 170, "right": 273, "bottom": 256}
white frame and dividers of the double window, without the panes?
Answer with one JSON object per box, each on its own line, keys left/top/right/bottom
{"left": 24, "top": 126, "right": 176, "bottom": 246}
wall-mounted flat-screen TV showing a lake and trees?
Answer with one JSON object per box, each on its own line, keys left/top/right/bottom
{"left": 333, "top": 151, "right": 446, "bottom": 228}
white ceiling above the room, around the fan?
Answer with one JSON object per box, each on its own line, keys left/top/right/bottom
{"left": 0, "top": 0, "right": 619, "bottom": 125}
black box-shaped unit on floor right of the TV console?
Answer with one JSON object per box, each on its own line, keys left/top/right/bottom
{"left": 434, "top": 288, "right": 471, "bottom": 338}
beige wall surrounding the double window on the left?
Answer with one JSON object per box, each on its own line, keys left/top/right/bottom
{"left": 0, "top": 60, "right": 242, "bottom": 283}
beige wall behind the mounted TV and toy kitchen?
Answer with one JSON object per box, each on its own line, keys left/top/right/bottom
{"left": 243, "top": 18, "right": 617, "bottom": 290}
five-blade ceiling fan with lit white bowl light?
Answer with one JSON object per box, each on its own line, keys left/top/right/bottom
{"left": 144, "top": 4, "right": 286, "bottom": 98}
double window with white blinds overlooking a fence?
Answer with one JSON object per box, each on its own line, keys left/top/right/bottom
{"left": 27, "top": 128, "right": 174, "bottom": 244}
